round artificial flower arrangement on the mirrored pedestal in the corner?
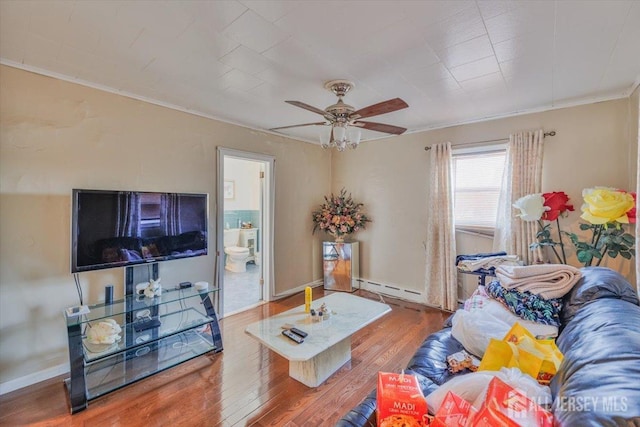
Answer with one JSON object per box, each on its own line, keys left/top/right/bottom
{"left": 311, "top": 188, "right": 371, "bottom": 241}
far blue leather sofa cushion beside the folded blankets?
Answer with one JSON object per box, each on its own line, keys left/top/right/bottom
{"left": 560, "top": 267, "right": 639, "bottom": 325}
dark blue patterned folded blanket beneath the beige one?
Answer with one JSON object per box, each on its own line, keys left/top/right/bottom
{"left": 486, "top": 281, "right": 562, "bottom": 326}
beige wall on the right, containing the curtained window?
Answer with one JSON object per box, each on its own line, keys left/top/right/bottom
{"left": 332, "top": 98, "right": 637, "bottom": 292}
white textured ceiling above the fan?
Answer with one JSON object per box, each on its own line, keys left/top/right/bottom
{"left": 0, "top": 0, "right": 640, "bottom": 142}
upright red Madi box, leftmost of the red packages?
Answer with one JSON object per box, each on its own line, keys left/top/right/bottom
{"left": 376, "top": 372, "right": 429, "bottom": 427}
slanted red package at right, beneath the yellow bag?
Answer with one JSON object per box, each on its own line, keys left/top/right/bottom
{"left": 471, "top": 378, "right": 553, "bottom": 427}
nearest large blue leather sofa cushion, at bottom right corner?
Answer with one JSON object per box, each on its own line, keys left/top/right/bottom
{"left": 551, "top": 298, "right": 640, "bottom": 427}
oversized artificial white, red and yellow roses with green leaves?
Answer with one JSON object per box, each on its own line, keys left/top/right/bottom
{"left": 513, "top": 187, "right": 636, "bottom": 267}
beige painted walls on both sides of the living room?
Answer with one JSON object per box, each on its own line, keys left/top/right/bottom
{"left": 0, "top": 61, "right": 638, "bottom": 392}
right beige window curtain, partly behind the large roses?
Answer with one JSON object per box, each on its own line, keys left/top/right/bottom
{"left": 493, "top": 130, "right": 544, "bottom": 265}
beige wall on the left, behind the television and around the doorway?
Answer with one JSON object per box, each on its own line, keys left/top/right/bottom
{"left": 0, "top": 66, "right": 331, "bottom": 384}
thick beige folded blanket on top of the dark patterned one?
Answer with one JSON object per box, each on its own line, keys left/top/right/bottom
{"left": 495, "top": 264, "right": 582, "bottom": 299}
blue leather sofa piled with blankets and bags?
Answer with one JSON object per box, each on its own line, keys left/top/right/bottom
{"left": 336, "top": 267, "right": 640, "bottom": 427}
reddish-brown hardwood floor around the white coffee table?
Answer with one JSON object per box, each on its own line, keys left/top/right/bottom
{"left": 0, "top": 288, "right": 448, "bottom": 427}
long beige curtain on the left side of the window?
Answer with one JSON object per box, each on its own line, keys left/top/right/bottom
{"left": 425, "top": 142, "right": 458, "bottom": 311}
